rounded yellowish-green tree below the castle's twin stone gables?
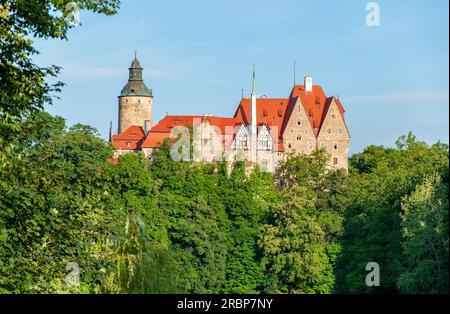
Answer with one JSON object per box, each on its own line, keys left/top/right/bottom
{"left": 259, "top": 186, "right": 334, "bottom": 293}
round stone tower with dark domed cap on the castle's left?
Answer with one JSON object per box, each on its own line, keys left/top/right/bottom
{"left": 118, "top": 55, "right": 153, "bottom": 133}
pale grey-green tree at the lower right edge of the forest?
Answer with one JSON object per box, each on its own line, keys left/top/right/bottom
{"left": 398, "top": 174, "right": 449, "bottom": 293}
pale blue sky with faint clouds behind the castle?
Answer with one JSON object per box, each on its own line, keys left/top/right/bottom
{"left": 35, "top": 0, "right": 449, "bottom": 153}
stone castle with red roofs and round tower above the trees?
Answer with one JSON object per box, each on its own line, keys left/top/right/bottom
{"left": 110, "top": 57, "right": 350, "bottom": 171}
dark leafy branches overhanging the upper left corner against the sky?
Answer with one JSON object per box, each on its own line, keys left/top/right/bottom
{"left": 0, "top": 0, "right": 119, "bottom": 146}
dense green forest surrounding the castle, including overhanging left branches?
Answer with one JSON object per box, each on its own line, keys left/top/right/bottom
{"left": 0, "top": 0, "right": 449, "bottom": 293}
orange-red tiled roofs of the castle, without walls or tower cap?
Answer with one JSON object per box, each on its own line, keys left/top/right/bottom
{"left": 112, "top": 85, "right": 345, "bottom": 151}
